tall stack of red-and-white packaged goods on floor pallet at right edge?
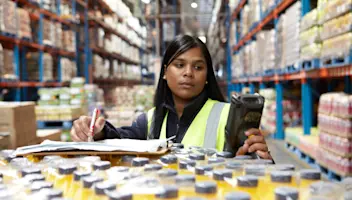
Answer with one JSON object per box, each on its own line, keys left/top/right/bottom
{"left": 317, "top": 93, "right": 352, "bottom": 175}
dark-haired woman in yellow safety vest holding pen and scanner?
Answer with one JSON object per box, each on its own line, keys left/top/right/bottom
{"left": 71, "top": 35, "right": 271, "bottom": 159}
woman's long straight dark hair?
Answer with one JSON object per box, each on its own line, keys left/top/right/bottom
{"left": 148, "top": 35, "right": 225, "bottom": 139}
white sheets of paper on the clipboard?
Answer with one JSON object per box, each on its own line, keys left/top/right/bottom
{"left": 14, "top": 137, "right": 174, "bottom": 155}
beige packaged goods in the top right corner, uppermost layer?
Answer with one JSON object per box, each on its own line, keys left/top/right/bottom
{"left": 320, "top": 0, "right": 352, "bottom": 22}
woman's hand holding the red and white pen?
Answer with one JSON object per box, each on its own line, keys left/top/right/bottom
{"left": 71, "top": 116, "right": 105, "bottom": 142}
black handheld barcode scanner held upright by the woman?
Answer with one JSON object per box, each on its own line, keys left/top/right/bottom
{"left": 224, "top": 94, "right": 264, "bottom": 158}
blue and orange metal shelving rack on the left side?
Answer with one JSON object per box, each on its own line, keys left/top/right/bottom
{"left": 0, "top": 0, "right": 150, "bottom": 101}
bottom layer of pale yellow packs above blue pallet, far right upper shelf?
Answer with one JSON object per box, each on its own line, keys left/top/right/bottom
{"left": 321, "top": 32, "right": 352, "bottom": 58}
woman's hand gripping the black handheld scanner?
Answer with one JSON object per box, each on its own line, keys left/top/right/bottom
{"left": 236, "top": 128, "right": 273, "bottom": 160}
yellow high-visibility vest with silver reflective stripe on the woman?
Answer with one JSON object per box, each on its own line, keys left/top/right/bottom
{"left": 147, "top": 99, "right": 230, "bottom": 151}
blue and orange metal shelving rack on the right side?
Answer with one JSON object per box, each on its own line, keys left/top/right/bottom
{"left": 226, "top": 0, "right": 352, "bottom": 139}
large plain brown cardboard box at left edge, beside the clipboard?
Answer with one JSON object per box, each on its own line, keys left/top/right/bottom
{"left": 0, "top": 102, "right": 37, "bottom": 149}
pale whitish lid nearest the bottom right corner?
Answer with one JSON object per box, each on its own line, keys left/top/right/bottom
{"left": 309, "top": 181, "right": 343, "bottom": 196}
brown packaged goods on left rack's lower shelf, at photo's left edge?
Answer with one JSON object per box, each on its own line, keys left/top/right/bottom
{"left": 0, "top": 48, "right": 18, "bottom": 79}
